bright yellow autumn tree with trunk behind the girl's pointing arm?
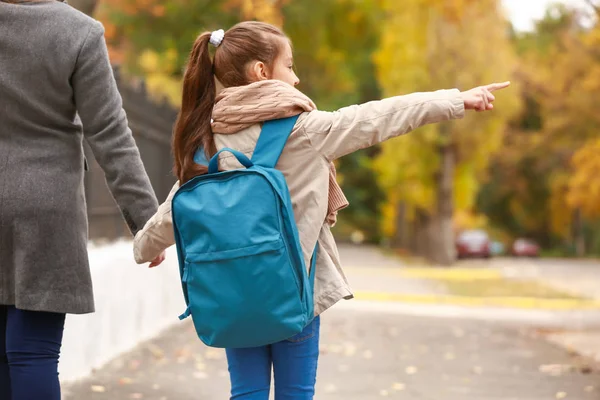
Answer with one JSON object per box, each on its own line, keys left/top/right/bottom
{"left": 376, "top": 0, "right": 519, "bottom": 265}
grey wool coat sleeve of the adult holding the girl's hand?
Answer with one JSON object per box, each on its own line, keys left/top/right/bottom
{"left": 71, "top": 22, "right": 158, "bottom": 235}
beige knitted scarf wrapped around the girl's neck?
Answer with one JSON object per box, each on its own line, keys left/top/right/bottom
{"left": 212, "top": 80, "right": 348, "bottom": 225}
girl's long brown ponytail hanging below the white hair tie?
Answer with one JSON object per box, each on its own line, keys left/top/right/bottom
{"left": 172, "top": 32, "right": 216, "bottom": 185}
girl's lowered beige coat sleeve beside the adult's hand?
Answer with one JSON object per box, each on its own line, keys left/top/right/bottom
{"left": 133, "top": 182, "right": 179, "bottom": 264}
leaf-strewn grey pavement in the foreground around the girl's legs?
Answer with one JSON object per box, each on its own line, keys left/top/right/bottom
{"left": 65, "top": 307, "right": 600, "bottom": 400}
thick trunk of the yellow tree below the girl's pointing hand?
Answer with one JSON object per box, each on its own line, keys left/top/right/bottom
{"left": 430, "top": 141, "right": 456, "bottom": 265}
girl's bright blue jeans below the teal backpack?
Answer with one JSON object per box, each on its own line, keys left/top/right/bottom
{"left": 227, "top": 317, "right": 320, "bottom": 400}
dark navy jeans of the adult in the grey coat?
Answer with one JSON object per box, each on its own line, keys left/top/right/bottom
{"left": 0, "top": 305, "right": 65, "bottom": 400}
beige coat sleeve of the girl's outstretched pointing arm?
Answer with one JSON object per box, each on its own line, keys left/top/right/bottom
{"left": 298, "top": 89, "right": 465, "bottom": 161}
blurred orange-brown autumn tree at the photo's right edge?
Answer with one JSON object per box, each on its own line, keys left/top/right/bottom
{"left": 480, "top": 5, "right": 600, "bottom": 255}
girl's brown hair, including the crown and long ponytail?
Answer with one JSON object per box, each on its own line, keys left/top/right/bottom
{"left": 172, "top": 21, "right": 288, "bottom": 184}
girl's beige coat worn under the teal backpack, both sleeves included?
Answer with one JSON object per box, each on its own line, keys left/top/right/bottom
{"left": 134, "top": 89, "right": 464, "bottom": 315}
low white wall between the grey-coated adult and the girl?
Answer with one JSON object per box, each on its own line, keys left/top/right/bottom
{"left": 59, "top": 241, "right": 185, "bottom": 382}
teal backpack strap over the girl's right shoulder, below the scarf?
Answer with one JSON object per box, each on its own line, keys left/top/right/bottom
{"left": 252, "top": 115, "right": 300, "bottom": 168}
